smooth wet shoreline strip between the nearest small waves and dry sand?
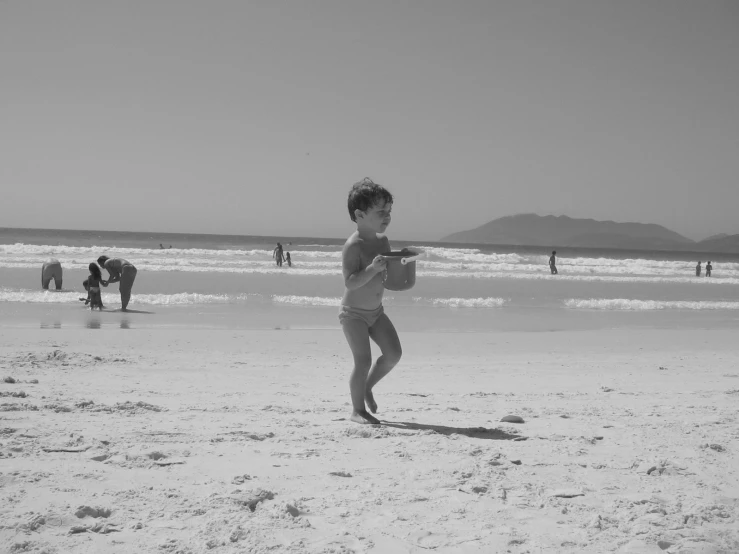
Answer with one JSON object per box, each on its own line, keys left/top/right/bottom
{"left": 0, "top": 295, "right": 739, "bottom": 336}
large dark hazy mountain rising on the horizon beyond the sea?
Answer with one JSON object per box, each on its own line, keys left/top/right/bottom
{"left": 441, "top": 214, "right": 696, "bottom": 250}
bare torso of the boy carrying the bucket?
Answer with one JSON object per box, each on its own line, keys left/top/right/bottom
{"left": 341, "top": 233, "right": 390, "bottom": 310}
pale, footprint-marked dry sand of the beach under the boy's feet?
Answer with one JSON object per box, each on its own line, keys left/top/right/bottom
{"left": 0, "top": 329, "right": 739, "bottom": 554}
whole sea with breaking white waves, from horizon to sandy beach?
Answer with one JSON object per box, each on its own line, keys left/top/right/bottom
{"left": 0, "top": 229, "right": 739, "bottom": 331}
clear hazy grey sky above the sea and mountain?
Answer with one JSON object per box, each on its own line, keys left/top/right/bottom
{"left": 0, "top": 0, "right": 739, "bottom": 239}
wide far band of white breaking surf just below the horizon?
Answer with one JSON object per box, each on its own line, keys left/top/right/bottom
{"left": 0, "top": 244, "right": 739, "bottom": 285}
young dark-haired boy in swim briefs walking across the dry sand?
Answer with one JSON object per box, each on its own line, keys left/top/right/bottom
{"left": 339, "top": 179, "right": 402, "bottom": 425}
